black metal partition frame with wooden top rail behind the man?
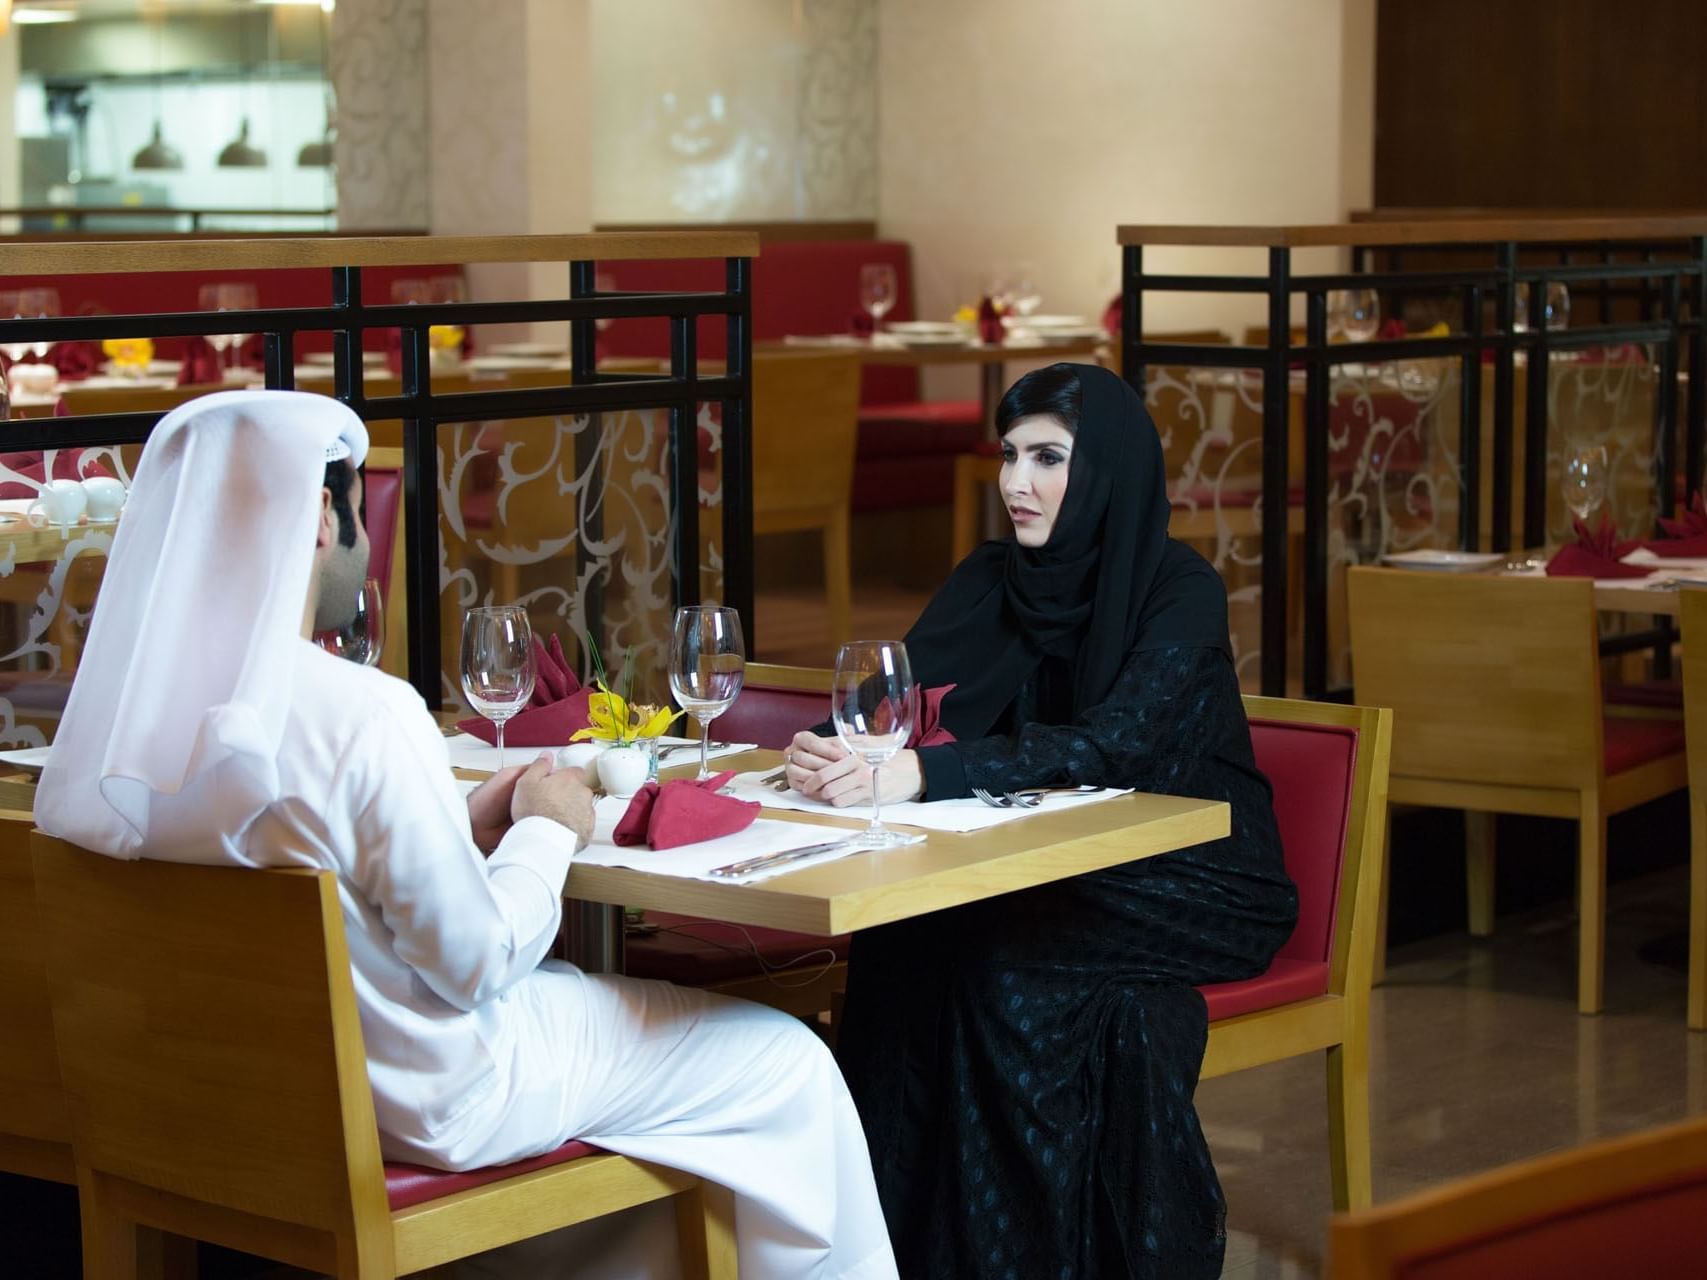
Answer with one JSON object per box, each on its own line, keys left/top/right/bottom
{"left": 0, "top": 232, "right": 758, "bottom": 708}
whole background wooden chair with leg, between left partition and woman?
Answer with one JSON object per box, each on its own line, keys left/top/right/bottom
{"left": 751, "top": 352, "right": 860, "bottom": 647}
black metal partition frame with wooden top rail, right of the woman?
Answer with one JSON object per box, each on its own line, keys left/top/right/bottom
{"left": 1118, "top": 217, "right": 1707, "bottom": 698}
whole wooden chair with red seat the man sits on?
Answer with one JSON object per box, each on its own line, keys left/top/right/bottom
{"left": 31, "top": 833, "right": 734, "bottom": 1280}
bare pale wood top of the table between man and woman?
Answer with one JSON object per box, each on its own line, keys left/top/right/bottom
{"left": 565, "top": 751, "right": 1231, "bottom": 935}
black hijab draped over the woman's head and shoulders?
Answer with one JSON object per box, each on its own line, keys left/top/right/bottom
{"left": 906, "top": 365, "right": 1232, "bottom": 739}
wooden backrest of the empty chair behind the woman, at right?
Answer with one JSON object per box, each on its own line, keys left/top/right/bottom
{"left": 1347, "top": 567, "right": 1605, "bottom": 790}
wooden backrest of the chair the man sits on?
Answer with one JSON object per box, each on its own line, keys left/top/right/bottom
{"left": 31, "top": 831, "right": 391, "bottom": 1273}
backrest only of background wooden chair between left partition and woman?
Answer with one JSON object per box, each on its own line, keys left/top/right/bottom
{"left": 753, "top": 352, "right": 860, "bottom": 527}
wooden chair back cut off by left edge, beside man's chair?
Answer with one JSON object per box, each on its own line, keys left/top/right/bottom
{"left": 0, "top": 814, "right": 73, "bottom": 1183}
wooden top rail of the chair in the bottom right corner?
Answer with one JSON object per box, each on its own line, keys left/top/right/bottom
{"left": 1328, "top": 1118, "right": 1707, "bottom": 1280}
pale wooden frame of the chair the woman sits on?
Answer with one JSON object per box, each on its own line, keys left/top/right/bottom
{"left": 1200, "top": 696, "right": 1393, "bottom": 1210}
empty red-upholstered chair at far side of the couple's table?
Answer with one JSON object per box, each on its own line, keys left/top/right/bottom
{"left": 623, "top": 662, "right": 848, "bottom": 1017}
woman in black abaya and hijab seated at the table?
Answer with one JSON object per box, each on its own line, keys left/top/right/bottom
{"left": 789, "top": 365, "right": 1297, "bottom": 1280}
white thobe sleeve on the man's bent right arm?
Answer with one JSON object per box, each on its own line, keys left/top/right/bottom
{"left": 340, "top": 708, "right": 577, "bottom": 1010}
